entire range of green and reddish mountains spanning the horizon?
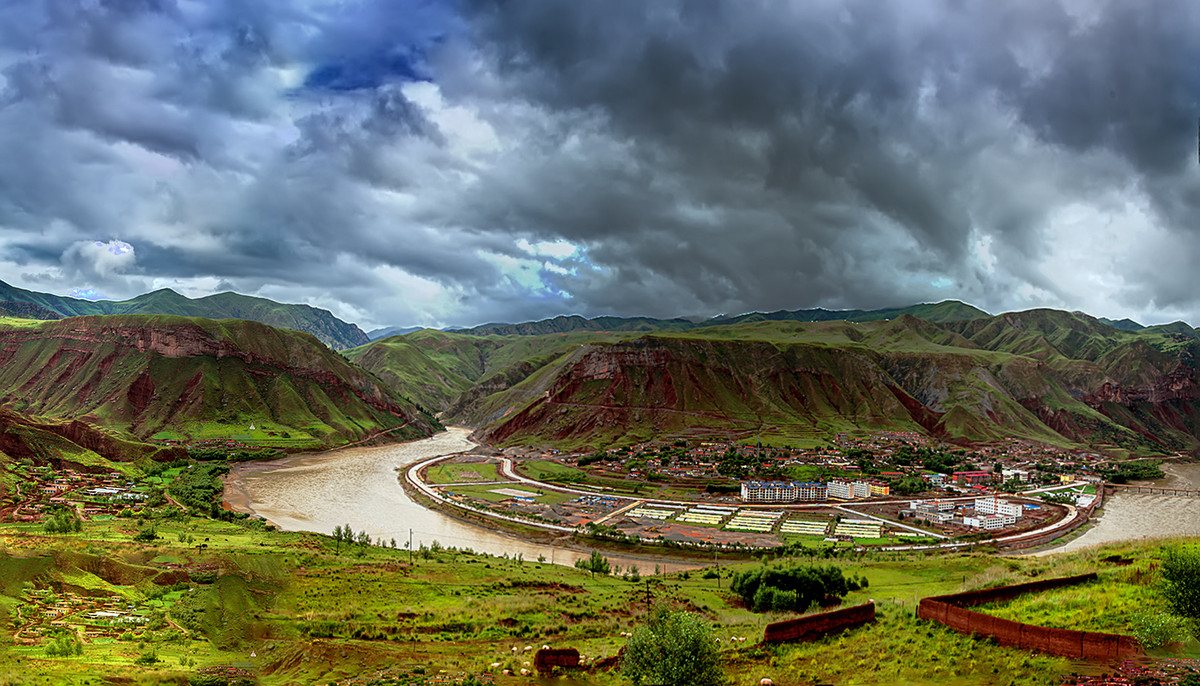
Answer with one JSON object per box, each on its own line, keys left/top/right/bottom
{"left": 0, "top": 281, "right": 1200, "bottom": 453}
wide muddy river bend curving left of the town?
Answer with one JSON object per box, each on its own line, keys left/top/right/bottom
{"left": 224, "top": 428, "right": 701, "bottom": 573}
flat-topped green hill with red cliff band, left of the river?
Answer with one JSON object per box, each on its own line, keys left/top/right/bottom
{"left": 0, "top": 315, "right": 437, "bottom": 446}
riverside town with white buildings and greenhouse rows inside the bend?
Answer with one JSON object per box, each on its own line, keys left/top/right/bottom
{"left": 414, "top": 432, "right": 1132, "bottom": 549}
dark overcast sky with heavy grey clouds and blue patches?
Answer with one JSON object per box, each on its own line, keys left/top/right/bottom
{"left": 0, "top": 0, "right": 1200, "bottom": 329}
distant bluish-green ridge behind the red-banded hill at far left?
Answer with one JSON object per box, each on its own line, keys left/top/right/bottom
{"left": 0, "top": 282, "right": 370, "bottom": 350}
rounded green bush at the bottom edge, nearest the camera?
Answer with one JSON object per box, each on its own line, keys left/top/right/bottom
{"left": 620, "top": 608, "right": 728, "bottom": 686}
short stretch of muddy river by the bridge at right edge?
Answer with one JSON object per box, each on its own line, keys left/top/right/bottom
{"left": 1039, "top": 463, "right": 1200, "bottom": 554}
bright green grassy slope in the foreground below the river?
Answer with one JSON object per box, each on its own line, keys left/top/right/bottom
{"left": 0, "top": 512, "right": 1198, "bottom": 686}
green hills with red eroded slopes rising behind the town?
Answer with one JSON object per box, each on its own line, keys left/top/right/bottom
{"left": 347, "top": 302, "right": 1200, "bottom": 452}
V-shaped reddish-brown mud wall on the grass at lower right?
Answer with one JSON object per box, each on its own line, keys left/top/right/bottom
{"left": 917, "top": 573, "right": 1141, "bottom": 661}
